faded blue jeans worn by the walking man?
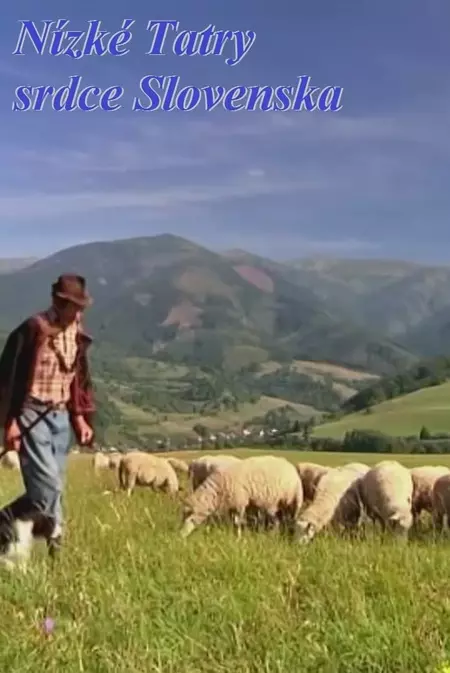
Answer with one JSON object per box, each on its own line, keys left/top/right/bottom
{"left": 0, "top": 403, "right": 70, "bottom": 537}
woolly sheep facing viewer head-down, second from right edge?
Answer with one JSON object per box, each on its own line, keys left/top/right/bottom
{"left": 359, "top": 460, "right": 413, "bottom": 537}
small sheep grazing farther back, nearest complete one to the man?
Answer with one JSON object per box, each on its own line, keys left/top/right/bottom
{"left": 119, "top": 452, "right": 179, "bottom": 496}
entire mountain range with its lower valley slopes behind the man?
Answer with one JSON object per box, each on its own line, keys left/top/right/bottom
{"left": 0, "top": 234, "right": 450, "bottom": 441}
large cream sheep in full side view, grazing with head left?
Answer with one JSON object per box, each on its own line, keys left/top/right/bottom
{"left": 181, "top": 456, "right": 303, "bottom": 538}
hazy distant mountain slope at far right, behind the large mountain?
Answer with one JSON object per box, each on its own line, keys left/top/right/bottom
{"left": 290, "top": 259, "right": 450, "bottom": 357}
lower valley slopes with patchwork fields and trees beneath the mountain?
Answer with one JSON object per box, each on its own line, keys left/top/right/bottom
{"left": 93, "top": 349, "right": 373, "bottom": 444}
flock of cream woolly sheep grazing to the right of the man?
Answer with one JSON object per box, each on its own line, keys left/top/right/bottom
{"left": 94, "top": 451, "right": 450, "bottom": 543}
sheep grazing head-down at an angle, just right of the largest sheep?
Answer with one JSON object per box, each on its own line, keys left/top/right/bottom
{"left": 295, "top": 464, "right": 364, "bottom": 544}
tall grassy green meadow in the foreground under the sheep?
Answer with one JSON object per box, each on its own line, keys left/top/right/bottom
{"left": 0, "top": 450, "right": 450, "bottom": 673}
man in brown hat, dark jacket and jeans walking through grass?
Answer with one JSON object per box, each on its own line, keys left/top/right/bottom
{"left": 0, "top": 275, "right": 95, "bottom": 567}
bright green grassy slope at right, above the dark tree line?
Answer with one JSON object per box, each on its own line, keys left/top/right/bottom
{"left": 314, "top": 382, "right": 450, "bottom": 438}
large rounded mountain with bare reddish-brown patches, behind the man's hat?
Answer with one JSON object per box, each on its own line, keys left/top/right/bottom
{"left": 0, "top": 234, "right": 415, "bottom": 374}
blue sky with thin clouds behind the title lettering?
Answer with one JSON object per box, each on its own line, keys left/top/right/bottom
{"left": 0, "top": 0, "right": 450, "bottom": 261}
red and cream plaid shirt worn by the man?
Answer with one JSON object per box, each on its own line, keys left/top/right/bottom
{"left": 29, "top": 309, "right": 78, "bottom": 405}
